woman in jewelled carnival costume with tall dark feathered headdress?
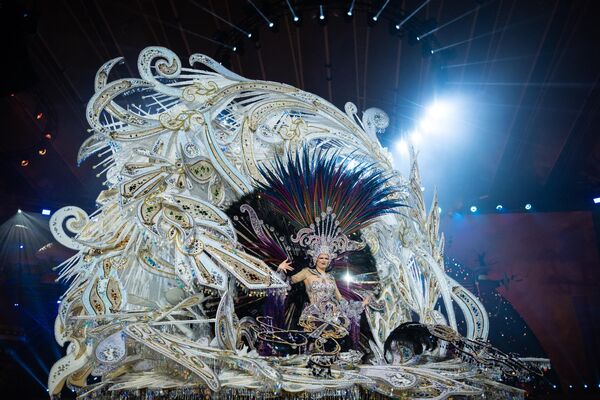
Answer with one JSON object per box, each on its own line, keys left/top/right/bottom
{"left": 230, "top": 147, "right": 401, "bottom": 349}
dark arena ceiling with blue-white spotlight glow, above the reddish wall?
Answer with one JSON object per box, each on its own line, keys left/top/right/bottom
{"left": 0, "top": 0, "right": 600, "bottom": 220}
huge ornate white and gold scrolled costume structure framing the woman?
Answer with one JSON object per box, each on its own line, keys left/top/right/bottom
{"left": 49, "top": 47, "right": 544, "bottom": 399}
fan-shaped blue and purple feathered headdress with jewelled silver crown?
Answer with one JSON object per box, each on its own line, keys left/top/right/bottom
{"left": 257, "top": 147, "right": 402, "bottom": 260}
